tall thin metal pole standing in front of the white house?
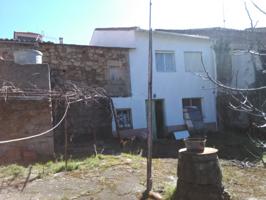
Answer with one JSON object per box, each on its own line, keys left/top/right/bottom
{"left": 147, "top": 0, "right": 152, "bottom": 192}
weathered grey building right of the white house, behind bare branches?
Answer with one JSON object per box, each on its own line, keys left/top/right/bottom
{"left": 160, "top": 27, "right": 266, "bottom": 129}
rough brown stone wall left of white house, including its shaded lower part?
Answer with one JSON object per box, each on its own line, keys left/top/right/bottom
{"left": 0, "top": 40, "right": 131, "bottom": 155}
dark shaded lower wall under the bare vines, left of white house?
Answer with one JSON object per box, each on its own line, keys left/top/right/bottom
{"left": 53, "top": 98, "right": 112, "bottom": 148}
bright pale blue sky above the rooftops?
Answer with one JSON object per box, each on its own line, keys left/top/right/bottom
{"left": 0, "top": 0, "right": 266, "bottom": 44}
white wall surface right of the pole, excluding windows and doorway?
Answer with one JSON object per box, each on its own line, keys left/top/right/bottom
{"left": 153, "top": 31, "right": 216, "bottom": 126}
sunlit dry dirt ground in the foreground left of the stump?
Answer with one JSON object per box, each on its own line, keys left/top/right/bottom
{"left": 0, "top": 155, "right": 177, "bottom": 200}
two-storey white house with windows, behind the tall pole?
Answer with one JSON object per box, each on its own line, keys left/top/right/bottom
{"left": 90, "top": 27, "right": 216, "bottom": 138}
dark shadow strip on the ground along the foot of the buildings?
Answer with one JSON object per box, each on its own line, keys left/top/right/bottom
{"left": 54, "top": 131, "right": 262, "bottom": 161}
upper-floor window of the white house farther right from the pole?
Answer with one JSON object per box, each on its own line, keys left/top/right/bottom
{"left": 184, "top": 51, "right": 204, "bottom": 72}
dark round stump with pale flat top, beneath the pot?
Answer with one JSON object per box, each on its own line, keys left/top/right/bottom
{"left": 175, "top": 147, "right": 230, "bottom": 200}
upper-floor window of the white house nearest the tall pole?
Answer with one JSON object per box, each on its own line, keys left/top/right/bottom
{"left": 155, "top": 51, "right": 176, "bottom": 72}
